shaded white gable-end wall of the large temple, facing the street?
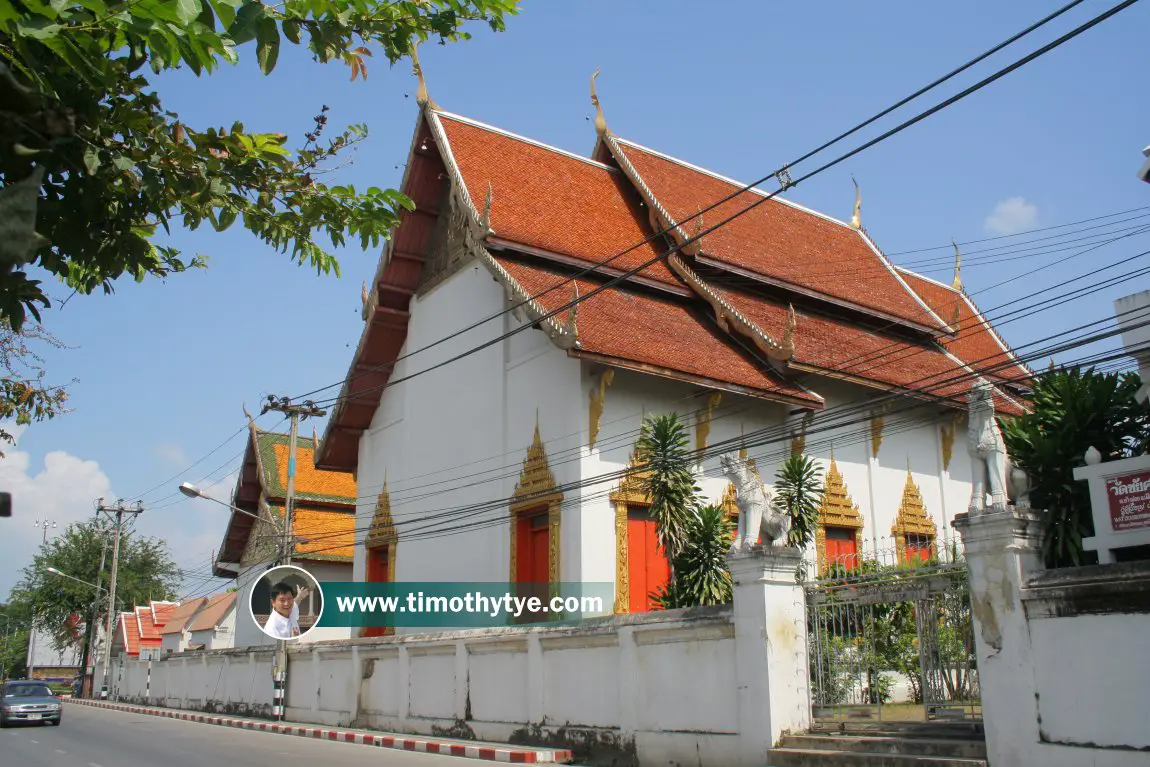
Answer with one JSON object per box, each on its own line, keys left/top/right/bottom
{"left": 354, "top": 266, "right": 587, "bottom": 607}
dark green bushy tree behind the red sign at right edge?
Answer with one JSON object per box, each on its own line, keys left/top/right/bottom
{"left": 999, "top": 368, "right": 1150, "bottom": 568}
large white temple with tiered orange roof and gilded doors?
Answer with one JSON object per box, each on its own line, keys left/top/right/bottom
{"left": 314, "top": 70, "right": 1032, "bottom": 630}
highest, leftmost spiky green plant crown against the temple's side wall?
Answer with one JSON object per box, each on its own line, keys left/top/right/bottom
{"left": 636, "top": 413, "right": 699, "bottom": 566}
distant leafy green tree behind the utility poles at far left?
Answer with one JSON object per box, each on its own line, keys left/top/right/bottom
{"left": 9, "top": 521, "right": 181, "bottom": 665}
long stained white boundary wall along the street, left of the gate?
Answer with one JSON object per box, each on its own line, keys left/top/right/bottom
{"left": 115, "top": 608, "right": 739, "bottom": 765}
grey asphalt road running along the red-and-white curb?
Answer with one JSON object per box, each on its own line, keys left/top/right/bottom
{"left": 0, "top": 704, "right": 495, "bottom": 767}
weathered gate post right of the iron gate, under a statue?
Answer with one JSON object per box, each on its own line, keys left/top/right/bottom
{"left": 952, "top": 507, "right": 1045, "bottom": 767}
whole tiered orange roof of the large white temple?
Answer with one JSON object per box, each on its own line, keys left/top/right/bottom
{"left": 315, "top": 93, "right": 1028, "bottom": 471}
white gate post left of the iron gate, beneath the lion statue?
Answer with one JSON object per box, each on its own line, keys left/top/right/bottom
{"left": 728, "top": 546, "right": 811, "bottom": 767}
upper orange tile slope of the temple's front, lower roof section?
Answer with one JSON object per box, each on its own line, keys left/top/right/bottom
{"left": 435, "top": 113, "right": 681, "bottom": 290}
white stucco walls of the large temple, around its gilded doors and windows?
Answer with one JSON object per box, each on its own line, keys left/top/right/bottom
{"left": 353, "top": 246, "right": 998, "bottom": 607}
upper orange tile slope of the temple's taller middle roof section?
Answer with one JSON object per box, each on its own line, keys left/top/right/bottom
{"left": 610, "top": 138, "right": 943, "bottom": 330}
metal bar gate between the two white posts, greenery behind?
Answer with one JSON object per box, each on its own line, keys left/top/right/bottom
{"left": 805, "top": 545, "right": 982, "bottom": 721}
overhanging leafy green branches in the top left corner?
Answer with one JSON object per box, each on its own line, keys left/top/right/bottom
{"left": 0, "top": 0, "right": 518, "bottom": 330}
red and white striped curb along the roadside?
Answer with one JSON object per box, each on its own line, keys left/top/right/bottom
{"left": 68, "top": 698, "right": 575, "bottom": 765}
